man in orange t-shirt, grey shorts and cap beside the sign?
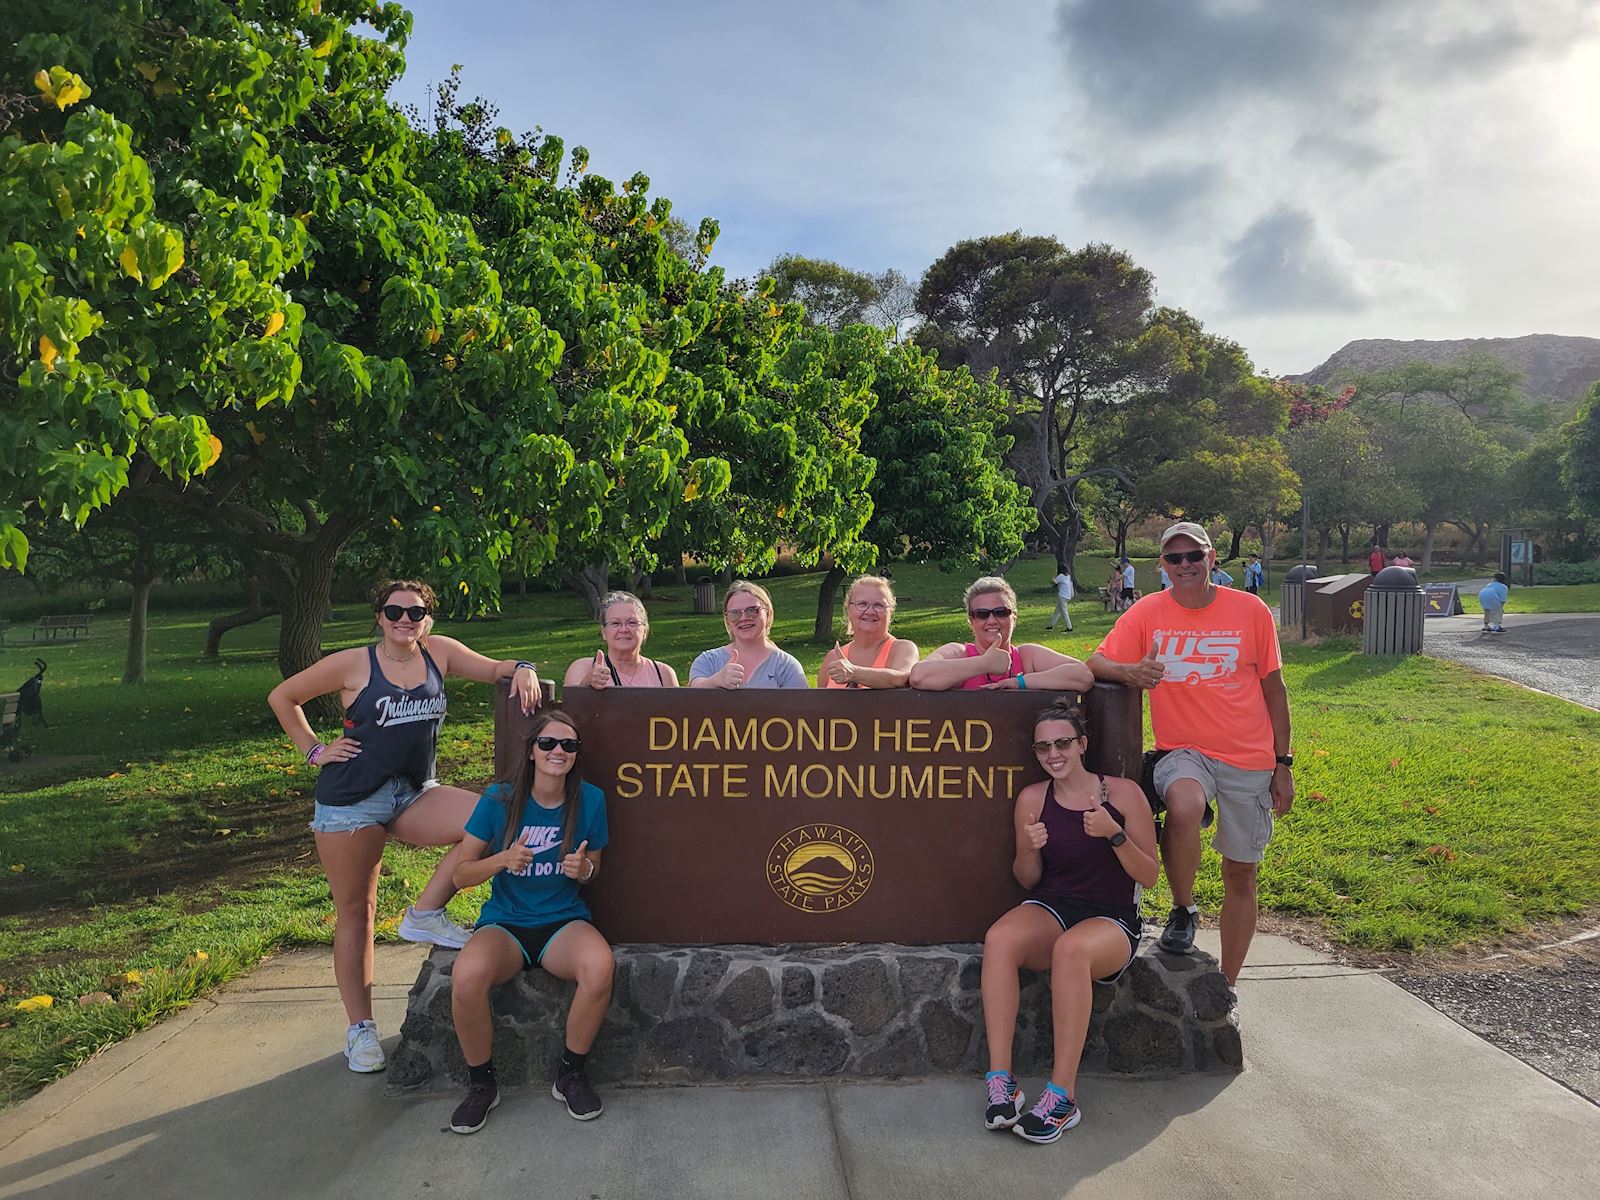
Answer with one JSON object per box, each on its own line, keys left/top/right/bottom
{"left": 1088, "top": 522, "right": 1294, "bottom": 984}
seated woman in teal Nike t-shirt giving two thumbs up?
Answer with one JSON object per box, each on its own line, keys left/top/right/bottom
{"left": 450, "top": 712, "right": 614, "bottom": 1133}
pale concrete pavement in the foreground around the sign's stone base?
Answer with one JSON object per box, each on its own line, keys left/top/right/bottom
{"left": 0, "top": 934, "right": 1600, "bottom": 1200}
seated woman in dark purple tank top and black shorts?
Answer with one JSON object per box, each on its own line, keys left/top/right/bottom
{"left": 982, "top": 704, "right": 1160, "bottom": 1142}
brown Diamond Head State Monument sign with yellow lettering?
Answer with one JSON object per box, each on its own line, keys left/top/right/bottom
{"left": 494, "top": 683, "right": 1141, "bottom": 944}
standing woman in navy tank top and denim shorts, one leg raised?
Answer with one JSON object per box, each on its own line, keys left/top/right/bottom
{"left": 267, "top": 579, "right": 539, "bottom": 1072}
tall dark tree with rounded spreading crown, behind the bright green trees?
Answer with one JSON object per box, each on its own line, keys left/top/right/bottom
{"left": 917, "top": 232, "right": 1166, "bottom": 570}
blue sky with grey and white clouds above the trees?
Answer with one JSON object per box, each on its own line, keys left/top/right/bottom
{"left": 387, "top": 0, "right": 1600, "bottom": 373}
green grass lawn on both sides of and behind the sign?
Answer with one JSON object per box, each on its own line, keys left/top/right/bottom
{"left": 0, "top": 560, "right": 1600, "bottom": 1099}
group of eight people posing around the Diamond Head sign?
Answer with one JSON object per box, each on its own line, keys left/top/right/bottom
{"left": 269, "top": 522, "right": 1294, "bottom": 1142}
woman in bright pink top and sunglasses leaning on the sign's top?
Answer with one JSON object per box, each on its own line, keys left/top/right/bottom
{"left": 910, "top": 574, "right": 1094, "bottom": 691}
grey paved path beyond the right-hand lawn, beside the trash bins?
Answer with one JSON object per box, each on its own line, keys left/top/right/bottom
{"left": 1422, "top": 611, "right": 1600, "bottom": 709}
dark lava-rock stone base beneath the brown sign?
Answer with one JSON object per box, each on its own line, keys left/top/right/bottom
{"left": 387, "top": 944, "right": 1243, "bottom": 1090}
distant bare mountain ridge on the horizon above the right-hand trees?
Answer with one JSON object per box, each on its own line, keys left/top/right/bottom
{"left": 1290, "top": 333, "right": 1600, "bottom": 400}
